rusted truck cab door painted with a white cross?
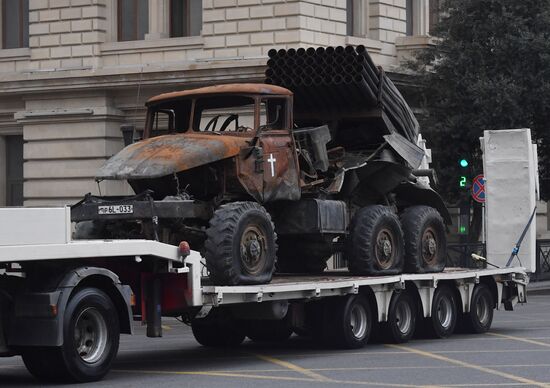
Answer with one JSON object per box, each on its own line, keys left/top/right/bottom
{"left": 260, "top": 97, "right": 301, "bottom": 202}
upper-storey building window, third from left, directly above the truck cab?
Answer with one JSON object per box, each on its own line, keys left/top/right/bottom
{"left": 170, "top": 0, "right": 202, "bottom": 38}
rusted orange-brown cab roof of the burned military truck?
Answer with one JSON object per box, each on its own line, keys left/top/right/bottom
{"left": 146, "top": 84, "right": 292, "bottom": 105}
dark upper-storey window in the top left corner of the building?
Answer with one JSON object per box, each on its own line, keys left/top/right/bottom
{"left": 1, "top": 0, "right": 29, "bottom": 49}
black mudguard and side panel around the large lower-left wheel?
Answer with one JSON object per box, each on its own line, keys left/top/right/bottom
{"left": 7, "top": 267, "right": 132, "bottom": 347}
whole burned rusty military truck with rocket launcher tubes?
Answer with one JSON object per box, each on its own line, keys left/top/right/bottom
{"left": 71, "top": 46, "right": 450, "bottom": 285}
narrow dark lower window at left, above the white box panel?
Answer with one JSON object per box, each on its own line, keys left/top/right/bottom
{"left": 5, "top": 136, "right": 23, "bottom": 206}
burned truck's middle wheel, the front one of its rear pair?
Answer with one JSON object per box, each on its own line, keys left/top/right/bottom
{"left": 346, "top": 205, "right": 405, "bottom": 275}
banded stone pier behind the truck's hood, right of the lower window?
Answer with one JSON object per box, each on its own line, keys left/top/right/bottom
{"left": 15, "top": 91, "right": 131, "bottom": 206}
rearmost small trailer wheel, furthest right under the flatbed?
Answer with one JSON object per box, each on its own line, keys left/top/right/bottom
{"left": 461, "top": 283, "right": 495, "bottom": 334}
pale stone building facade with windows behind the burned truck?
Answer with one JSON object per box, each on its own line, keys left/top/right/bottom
{"left": 0, "top": 0, "right": 440, "bottom": 206}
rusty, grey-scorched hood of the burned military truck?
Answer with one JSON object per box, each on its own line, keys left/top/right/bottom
{"left": 96, "top": 133, "right": 248, "bottom": 180}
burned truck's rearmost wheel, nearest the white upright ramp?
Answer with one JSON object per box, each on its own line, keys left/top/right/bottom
{"left": 401, "top": 206, "right": 447, "bottom": 273}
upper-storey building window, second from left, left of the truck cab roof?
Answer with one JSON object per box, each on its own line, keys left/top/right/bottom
{"left": 117, "top": 0, "right": 149, "bottom": 41}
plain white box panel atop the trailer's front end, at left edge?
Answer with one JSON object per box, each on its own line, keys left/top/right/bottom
{"left": 0, "top": 207, "right": 71, "bottom": 246}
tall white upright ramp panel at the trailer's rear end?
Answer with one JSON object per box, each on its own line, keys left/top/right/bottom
{"left": 482, "top": 129, "right": 537, "bottom": 272}
